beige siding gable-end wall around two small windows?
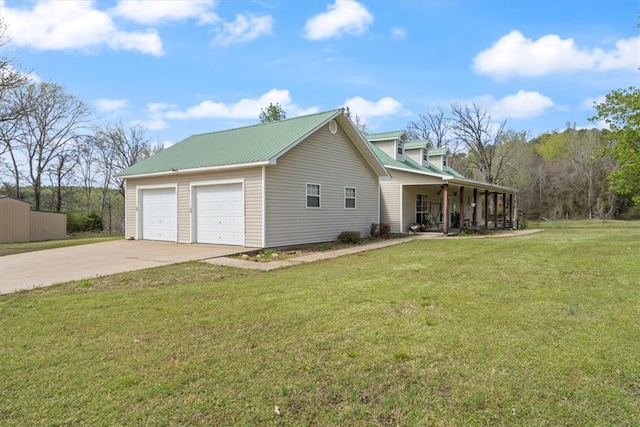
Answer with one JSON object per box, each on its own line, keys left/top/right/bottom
{"left": 265, "top": 122, "right": 379, "bottom": 247}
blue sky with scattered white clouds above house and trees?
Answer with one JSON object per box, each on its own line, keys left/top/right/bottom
{"left": 0, "top": 0, "right": 640, "bottom": 144}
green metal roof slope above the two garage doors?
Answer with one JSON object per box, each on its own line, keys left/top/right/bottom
{"left": 116, "top": 109, "right": 343, "bottom": 178}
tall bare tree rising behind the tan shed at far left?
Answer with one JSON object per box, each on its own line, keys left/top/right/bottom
{"left": 17, "top": 83, "right": 89, "bottom": 210}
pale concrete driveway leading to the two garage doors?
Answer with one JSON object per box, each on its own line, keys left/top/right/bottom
{"left": 0, "top": 239, "right": 255, "bottom": 294}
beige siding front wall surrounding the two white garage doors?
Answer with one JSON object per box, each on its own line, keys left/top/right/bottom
{"left": 125, "top": 167, "right": 262, "bottom": 247}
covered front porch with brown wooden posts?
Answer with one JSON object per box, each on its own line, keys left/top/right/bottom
{"left": 401, "top": 181, "right": 517, "bottom": 235}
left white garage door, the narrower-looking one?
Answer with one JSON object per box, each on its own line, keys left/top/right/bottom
{"left": 140, "top": 188, "right": 178, "bottom": 242}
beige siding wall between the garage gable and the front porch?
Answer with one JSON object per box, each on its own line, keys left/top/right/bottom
{"left": 380, "top": 170, "right": 443, "bottom": 233}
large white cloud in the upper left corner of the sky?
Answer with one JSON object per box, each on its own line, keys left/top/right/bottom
{"left": 2, "top": 1, "right": 163, "bottom": 56}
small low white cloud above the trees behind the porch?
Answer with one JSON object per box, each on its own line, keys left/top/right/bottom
{"left": 476, "top": 90, "right": 554, "bottom": 120}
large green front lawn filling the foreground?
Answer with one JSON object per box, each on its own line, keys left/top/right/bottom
{"left": 0, "top": 222, "right": 640, "bottom": 426}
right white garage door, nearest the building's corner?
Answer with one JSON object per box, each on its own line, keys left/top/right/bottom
{"left": 194, "top": 183, "right": 244, "bottom": 245}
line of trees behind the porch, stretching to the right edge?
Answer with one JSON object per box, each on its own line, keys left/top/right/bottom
{"left": 407, "top": 93, "right": 640, "bottom": 219}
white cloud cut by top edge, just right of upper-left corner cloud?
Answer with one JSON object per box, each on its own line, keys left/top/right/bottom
{"left": 112, "top": 0, "right": 219, "bottom": 24}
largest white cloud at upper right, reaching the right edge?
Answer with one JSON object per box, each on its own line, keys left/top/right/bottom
{"left": 473, "top": 31, "right": 640, "bottom": 77}
